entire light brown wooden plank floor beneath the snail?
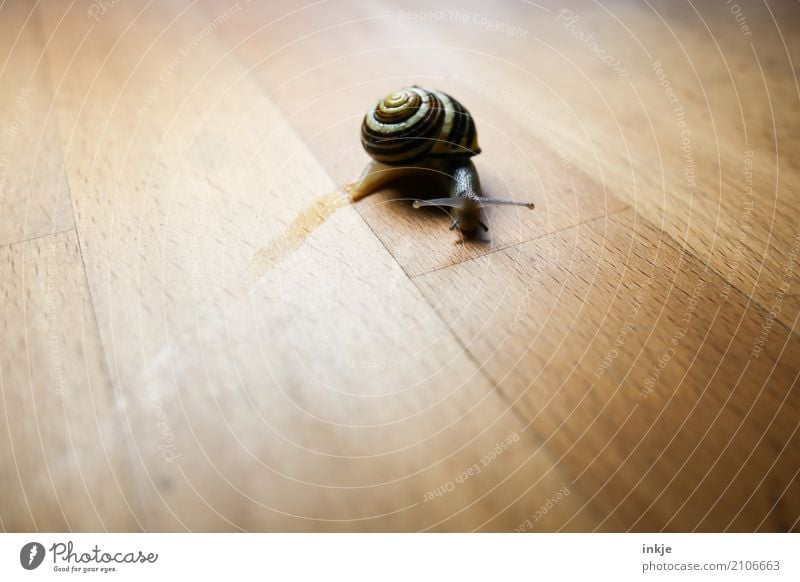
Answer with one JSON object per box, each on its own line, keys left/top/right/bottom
{"left": 0, "top": 0, "right": 800, "bottom": 531}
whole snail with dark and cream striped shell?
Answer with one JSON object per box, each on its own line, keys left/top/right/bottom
{"left": 350, "top": 85, "right": 534, "bottom": 233}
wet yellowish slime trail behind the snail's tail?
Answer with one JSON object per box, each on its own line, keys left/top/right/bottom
{"left": 247, "top": 185, "right": 351, "bottom": 281}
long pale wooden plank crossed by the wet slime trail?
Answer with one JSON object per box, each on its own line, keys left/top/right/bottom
{"left": 40, "top": 3, "right": 592, "bottom": 530}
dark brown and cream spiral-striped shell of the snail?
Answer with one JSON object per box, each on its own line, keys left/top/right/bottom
{"left": 361, "top": 86, "right": 481, "bottom": 165}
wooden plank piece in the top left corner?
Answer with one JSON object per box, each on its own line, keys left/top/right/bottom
{"left": 0, "top": 2, "right": 74, "bottom": 245}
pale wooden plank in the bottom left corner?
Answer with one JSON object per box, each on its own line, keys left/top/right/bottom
{"left": 0, "top": 231, "right": 141, "bottom": 531}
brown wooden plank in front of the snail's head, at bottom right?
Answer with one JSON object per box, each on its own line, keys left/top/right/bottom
{"left": 417, "top": 211, "right": 800, "bottom": 531}
